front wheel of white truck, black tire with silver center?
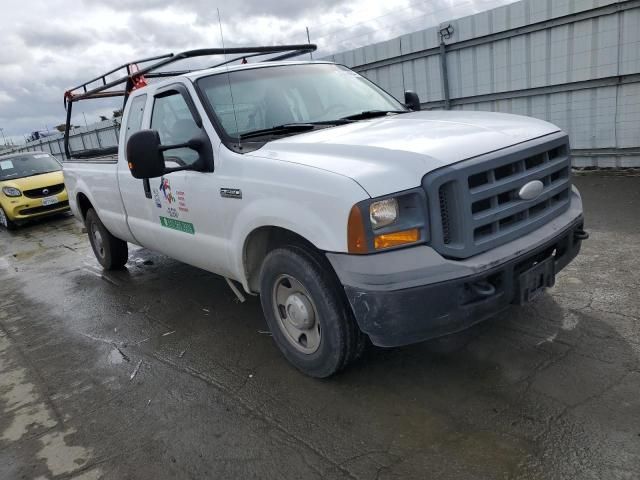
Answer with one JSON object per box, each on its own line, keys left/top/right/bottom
{"left": 260, "top": 246, "right": 365, "bottom": 378}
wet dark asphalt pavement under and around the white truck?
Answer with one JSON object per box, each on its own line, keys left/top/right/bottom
{"left": 0, "top": 174, "right": 640, "bottom": 479}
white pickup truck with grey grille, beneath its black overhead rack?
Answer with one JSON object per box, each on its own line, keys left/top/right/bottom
{"left": 64, "top": 49, "right": 588, "bottom": 377}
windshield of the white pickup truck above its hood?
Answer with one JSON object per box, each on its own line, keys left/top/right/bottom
{"left": 198, "top": 64, "right": 406, "bottom": 137}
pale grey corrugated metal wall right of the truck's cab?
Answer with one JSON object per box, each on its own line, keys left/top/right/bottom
{"left": 329, "top": 0, "right": 640, "bottom": 167}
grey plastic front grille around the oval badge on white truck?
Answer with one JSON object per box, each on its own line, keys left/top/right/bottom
{"left": 423, "top": 134, "right": 571, "bottom": 258}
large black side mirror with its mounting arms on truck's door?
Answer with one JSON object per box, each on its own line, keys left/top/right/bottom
{"left": 127, "top": 130, "right": 205, "bottom": 180}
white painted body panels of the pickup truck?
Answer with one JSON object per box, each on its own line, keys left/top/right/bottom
{"left": 64, "top": 62, "right": 559, "bottom": 289}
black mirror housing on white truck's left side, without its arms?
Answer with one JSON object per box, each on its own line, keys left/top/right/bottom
{"left": 127, "top": 130, "right": 165, "bottom": 179}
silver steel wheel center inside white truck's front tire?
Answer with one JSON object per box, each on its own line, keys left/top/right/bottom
{"left": 273, "top": 275, "right": 321, "bottom": 354}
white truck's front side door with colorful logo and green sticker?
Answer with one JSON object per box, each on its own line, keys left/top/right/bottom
{"left": 121, "top": 85, "right": 234, "bottom": 274}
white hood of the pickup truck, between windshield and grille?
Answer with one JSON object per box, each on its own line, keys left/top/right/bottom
{"left": 253, "top": 111, "right": 560, "bottom": 197}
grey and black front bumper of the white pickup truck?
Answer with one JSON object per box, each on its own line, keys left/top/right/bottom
{"left": 327, "top": 186, "right": 583, "bottom": 347}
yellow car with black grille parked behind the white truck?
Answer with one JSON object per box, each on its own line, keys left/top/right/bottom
{"left": 0, "top": 152, "right": 69, "bottom": 230}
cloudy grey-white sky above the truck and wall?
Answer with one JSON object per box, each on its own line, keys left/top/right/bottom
{"left": 0, "top": 0, "right": 513, "bottom": 144}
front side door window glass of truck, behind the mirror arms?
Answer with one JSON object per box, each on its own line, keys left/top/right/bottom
{"left": 151, "top": 92, "right": 200, "bottom": 167}
